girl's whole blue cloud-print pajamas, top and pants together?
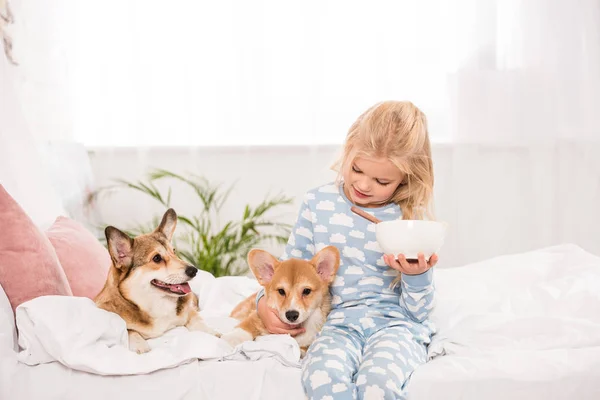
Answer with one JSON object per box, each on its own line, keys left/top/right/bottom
{"left": 257, "top": 184, "right": 434, "bottom": 400}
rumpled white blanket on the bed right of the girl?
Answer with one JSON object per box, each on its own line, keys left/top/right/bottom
{"left": 429, "top": 245, "right": 600, "bottom": 358}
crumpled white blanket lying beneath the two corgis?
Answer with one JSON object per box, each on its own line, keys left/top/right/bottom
{"left": 16, "top": 276, "right": 300, "bottom": 375}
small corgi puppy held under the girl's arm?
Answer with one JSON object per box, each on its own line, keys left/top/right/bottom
{"left": 222, "top": 246, "right": 340, "bottom": 356}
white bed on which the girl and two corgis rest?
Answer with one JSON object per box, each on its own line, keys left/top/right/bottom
{"left": 0, "top": 241, "right": 600, "bottom": 400}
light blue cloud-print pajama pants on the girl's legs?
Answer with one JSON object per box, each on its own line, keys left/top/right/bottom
{"left": 302, "top": 320, "right": 427, "bottom": 400}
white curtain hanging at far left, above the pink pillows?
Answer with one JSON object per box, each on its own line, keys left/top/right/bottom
{"left": 0, "top": 0, "right": 93, "bottom": 228}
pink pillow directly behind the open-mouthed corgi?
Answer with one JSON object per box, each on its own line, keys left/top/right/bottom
{"left": 46, "top": 217, "right": 111, "bottom": 299}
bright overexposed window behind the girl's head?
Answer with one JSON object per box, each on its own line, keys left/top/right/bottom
{"left": 69, "top": 0, "right": 480, "bottom": 146}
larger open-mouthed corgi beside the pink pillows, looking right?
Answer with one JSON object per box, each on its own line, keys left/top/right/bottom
{"left": 94, "top": 209, "right": 219, "bottom": 354}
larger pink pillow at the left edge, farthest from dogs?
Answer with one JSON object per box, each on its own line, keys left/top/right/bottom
{"left": 0, "top": 185, "right": 72, "bottom": 311}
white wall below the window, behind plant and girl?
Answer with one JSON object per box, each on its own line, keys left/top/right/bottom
{"left": 91, "top": 142, "right": 600, "bottom": 266}
